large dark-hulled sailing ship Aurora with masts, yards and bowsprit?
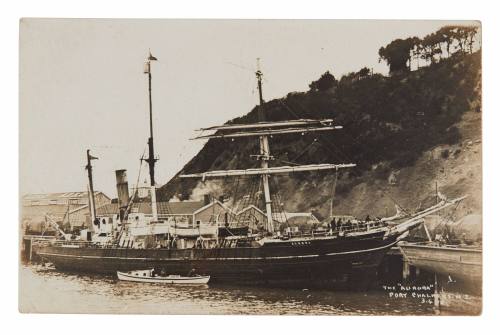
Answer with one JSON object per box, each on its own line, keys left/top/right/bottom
{"left": 37, "top": 53, "right": 463, "bottom": 289}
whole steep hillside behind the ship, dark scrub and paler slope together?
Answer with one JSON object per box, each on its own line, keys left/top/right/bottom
{"left": 158, "top": 51, "right": 482, "bottom": 217}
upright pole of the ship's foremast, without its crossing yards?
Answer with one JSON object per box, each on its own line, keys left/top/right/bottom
{"left": 255, "top": 58, "right": 274, "bottom": 233}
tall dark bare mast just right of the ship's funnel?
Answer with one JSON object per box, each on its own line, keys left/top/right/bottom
{"left": 144, "top": 51, "right": 158, "bottom": 221}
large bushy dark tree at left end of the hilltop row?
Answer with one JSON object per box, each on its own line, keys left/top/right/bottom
{"left": 378, "top": 37, "right": 420, "bottom": 74}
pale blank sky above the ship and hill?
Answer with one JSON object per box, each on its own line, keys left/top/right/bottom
{"left": 19, "top": 19, "right": 474, "bottom": 197}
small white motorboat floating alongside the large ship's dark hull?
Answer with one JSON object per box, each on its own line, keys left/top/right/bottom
{"left": 116, "top": 269, "right": 210, "bottom": 285}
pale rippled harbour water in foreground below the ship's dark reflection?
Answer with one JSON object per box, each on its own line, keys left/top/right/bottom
{"left": 19, "top": 265, "right": 480, "bottom": 315}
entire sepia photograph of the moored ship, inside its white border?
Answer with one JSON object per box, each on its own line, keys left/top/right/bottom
{"left": 18, "top": 18, "right": 483, "bottom": 317}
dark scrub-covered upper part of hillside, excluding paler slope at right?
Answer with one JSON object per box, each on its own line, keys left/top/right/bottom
{"left": 158, "top": 52, "right": 481, "bottom": 220}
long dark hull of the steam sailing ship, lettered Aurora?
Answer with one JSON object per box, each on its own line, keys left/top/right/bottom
{"left": 37, "top": 233, "right": 396, "bottom": 288}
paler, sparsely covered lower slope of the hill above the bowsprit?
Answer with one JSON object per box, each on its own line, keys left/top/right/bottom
{"left": 321, "top": 111, "right": 482, "bottom": 217}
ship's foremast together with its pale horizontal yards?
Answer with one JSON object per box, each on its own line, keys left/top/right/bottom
{"left": 180, "top": 59, "right": 356, "bottom": 233}
